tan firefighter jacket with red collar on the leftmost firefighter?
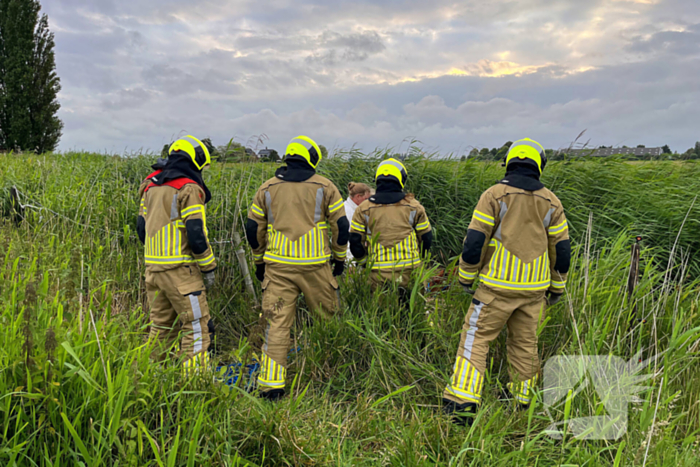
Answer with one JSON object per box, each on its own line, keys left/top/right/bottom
{"left": 138, "top": 178, "right": 216, "bottom": 272}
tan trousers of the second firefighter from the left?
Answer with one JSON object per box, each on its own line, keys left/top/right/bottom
{"left": 258, "top": 263, "right": 340, "bottom": 391}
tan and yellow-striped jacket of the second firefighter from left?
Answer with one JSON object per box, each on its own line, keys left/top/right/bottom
{"left": 246, "top": 174, "right": 348, "bottom": 267}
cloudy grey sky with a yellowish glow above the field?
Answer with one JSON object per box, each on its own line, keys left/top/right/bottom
{"left": 43, "top": 0, "right": 700, "bottom": 153}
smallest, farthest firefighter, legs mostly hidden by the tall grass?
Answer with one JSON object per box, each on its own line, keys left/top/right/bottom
{"left": 350, "top": 159, "right": 433, "bottom": 288}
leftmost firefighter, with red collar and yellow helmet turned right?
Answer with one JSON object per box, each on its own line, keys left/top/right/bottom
{"left": 137, "top": 136, "right": 216, "bottom": 371}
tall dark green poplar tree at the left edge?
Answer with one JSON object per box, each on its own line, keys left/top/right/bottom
{"left": 0, "top": 0, "right": 63, "bottom": 153}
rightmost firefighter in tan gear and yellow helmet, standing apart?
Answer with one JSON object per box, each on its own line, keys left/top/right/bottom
{"left": 443, "top": 138, "right": 571, "bottom": 425}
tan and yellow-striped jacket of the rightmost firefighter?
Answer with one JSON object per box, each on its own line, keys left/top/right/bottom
{"left": 459, "top": 183, "right": 571, "bottom": 294}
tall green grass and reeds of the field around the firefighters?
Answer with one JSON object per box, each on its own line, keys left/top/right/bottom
{"left": 0, "top": 153, "right": 700, "bottom": 467}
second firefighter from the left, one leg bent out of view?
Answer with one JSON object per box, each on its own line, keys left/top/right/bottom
{"left": 246, "top": 136, "right": 349, "bottom": 400}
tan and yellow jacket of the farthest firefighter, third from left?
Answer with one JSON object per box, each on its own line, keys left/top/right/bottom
{"left": 350, "top": 195, "right": 432, "bottom": 270}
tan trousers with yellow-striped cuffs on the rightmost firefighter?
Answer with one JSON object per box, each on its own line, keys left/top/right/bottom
{"left": 443, "top": 285, "right": 546, "bottom": 404}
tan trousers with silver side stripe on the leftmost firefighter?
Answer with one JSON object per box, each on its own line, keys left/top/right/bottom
{"left": 146, "top": 265, "right": 210, "bottom": 368}
